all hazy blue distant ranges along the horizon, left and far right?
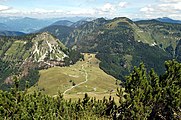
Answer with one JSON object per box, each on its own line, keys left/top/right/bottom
{"left": 0, "top": 17, "right": 181, "bottom": 33}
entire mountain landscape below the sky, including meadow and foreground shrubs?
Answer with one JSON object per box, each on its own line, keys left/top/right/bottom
{"left": 0, "top": 13, "right": 181, "bottom": 120}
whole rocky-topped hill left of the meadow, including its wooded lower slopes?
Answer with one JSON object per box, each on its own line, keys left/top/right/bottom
{"left": 0, "top": 32, "right": 80, "bottom": 89}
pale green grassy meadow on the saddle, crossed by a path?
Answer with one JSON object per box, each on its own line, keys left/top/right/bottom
{"left": 29, "top": 54, "right": 118, "bottom": 99}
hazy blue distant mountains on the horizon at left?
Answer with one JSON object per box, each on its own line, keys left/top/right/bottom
{"left": 0, "top": 17, "right": 96, "bottom": 33}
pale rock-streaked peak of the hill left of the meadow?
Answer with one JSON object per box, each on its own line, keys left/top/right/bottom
{"left": 32, "top": 32, "right": 68, "bottom": 62}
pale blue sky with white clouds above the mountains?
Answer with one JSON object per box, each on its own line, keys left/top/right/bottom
{"left": 0, "top": 0, "right": 181, "bottom": 20}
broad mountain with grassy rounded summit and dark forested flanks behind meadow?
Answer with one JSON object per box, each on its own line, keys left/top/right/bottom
{"left": 66, "top": 17, "right": 176, "bottom": 80}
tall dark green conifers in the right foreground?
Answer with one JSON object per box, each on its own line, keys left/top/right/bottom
{"left": 117, "top": 60, "right": 181, "bottom": 120}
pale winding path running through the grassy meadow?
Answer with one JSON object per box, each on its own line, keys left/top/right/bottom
{"left": 63, "top": 63, "right": 88, "bottom": 95}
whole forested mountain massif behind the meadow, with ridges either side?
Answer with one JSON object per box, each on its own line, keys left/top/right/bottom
{"left": 37, "top": 17, "right": 181, "bottom": 80}
